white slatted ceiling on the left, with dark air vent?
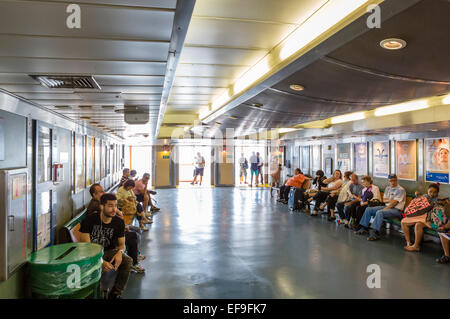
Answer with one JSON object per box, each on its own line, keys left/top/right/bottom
{"left": 0, "top": 0, "right": 176, "bottom": 141}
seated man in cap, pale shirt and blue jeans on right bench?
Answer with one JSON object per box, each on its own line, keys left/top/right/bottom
{"left": 358, "top": 174, "right": 406, "bottom": 241}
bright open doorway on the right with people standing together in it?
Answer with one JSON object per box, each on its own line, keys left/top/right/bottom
{"left": 234, "top": 146, "right": 267, "bottom": 187}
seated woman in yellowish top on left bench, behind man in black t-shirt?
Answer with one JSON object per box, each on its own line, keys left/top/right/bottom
{"left": 117, "top": 180, "right": 152, "bottom": 231}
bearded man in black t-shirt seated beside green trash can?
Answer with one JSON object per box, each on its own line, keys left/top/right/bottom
{"left": 80, "top": 194, "right": 133, "bottom": 299}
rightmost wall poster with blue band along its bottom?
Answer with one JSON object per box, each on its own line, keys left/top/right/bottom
{"left": 425, "top": 137, "right": 449, "bottom": 184}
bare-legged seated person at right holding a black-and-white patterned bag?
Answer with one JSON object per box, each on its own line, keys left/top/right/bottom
{"left": 402, "top": 183, "right": 443, "bottom": 251}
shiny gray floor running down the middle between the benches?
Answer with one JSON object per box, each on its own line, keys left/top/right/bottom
{"left": 124, "top": 188, "right": 450, "bottom": 298}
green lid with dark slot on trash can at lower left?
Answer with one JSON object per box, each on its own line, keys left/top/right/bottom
{"left": 29, "top": 243, "right": 103, "bottom": 271}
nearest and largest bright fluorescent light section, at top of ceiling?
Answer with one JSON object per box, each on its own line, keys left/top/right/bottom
{"left": 280, "top": 0, "right": 369, "bottom": 60}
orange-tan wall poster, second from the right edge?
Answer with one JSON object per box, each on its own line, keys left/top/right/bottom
{"left": 396, "top": 140, "right": 416, "bottom": 181}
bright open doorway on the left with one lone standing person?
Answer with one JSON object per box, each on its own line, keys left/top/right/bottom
{"left": 178, "top": 145, "right": 211, "bottom": 188}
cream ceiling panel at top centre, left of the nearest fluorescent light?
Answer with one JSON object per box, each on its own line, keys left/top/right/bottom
{"left": 194, "top": 0, "right": 328, "bottom": 24}
